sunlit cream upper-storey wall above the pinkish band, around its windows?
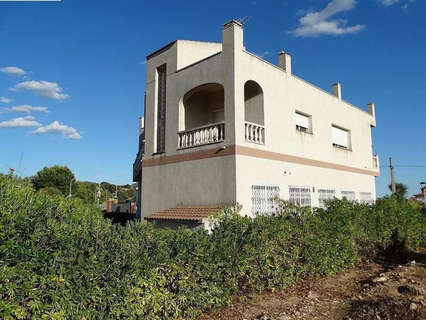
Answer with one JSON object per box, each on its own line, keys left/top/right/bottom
{"left": 236, "top": 52, "right": 374, "bottom": 169}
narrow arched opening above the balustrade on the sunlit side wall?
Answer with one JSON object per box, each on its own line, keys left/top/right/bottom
{"left": 244, "top": 80, "right": 264, "bottom": 126}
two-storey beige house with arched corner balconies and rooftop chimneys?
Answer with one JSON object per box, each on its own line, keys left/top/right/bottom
{"left": 133, "top": 20, "right": 379, "bottom": 226}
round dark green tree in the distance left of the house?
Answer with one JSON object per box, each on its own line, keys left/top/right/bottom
{"left": 32, "top": 166, "right": 75, "bottom": 196}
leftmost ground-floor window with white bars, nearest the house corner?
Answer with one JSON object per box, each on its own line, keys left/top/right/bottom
{"left": 251, "top": 185, "right": 280, "bottom": 215}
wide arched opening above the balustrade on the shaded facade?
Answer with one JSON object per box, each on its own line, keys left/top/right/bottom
{"left": 183, "top": 83, "right": 225, "bottom": 131}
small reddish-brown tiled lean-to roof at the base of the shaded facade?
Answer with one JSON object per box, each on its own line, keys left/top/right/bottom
{"left": 145, "top": 207, "right": 220, "bottom": 221}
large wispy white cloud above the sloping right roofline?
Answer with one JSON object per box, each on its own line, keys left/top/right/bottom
{"left": 290, "top": 0, "right": 365, "bottom": 37}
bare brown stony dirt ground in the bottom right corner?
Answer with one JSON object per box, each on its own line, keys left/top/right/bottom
{"left": 200, "top": 256, "right": 426, "bottom": 320}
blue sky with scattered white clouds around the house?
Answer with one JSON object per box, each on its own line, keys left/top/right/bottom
{"left": 0, "top": 0, "right": 426, "bottom": 195}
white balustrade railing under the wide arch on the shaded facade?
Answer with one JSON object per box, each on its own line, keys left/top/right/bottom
{"left": 178, "top": 122, "right": 225, "bottom": 149}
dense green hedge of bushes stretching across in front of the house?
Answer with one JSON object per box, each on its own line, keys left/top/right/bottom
{"left": 0, "top": 177, "right": 426, "bottom": 319}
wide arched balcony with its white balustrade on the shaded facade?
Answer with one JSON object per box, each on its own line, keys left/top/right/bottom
{"left": 178, "top": 83, "right": 225, "bottom": 149}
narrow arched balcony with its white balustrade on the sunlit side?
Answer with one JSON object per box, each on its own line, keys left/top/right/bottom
{"left": 244, "top": 80, "right": 265, "bottom": 144}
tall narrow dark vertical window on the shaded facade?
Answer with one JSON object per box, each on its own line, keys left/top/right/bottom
{"left": 156, "top": 64, "right": 167, "bottom": 152}
